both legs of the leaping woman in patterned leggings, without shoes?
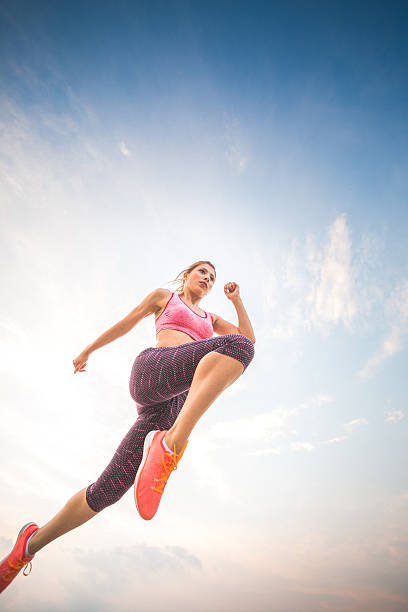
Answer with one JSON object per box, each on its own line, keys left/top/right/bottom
{"left": 28, "top": 334, "right": 254, "bottom": 554}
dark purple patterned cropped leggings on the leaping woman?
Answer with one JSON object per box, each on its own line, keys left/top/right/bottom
{"left": 86, "top": 334, "right": 254, "bottom": 512}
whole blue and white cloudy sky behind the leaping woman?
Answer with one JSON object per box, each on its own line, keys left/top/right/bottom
{"left": 0, "top": 1, "right": 408, "bottom": 612}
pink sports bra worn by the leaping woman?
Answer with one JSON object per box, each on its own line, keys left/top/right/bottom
{"left": 155, "top": 293, "right": 213, "bottom": 340}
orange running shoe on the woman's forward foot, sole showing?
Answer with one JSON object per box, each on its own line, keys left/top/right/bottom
{"left": 135, "top": 430, "right": 188, "bottom": 521}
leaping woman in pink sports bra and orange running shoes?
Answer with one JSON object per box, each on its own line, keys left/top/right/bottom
{"left": 0, "top": 261, "right": 255, "bottom": 592}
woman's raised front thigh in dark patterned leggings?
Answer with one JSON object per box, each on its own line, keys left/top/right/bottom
{"left": 129, "top": 334, "right": 254, "bottom": 407}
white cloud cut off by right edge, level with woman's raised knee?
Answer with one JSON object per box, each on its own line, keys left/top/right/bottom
{"left": 359, "top": 280, "right": 408, "bottom": 378}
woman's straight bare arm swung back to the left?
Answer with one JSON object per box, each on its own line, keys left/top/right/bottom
{"left": 73, "top": 289, "right": 169, "bottom": 374}
